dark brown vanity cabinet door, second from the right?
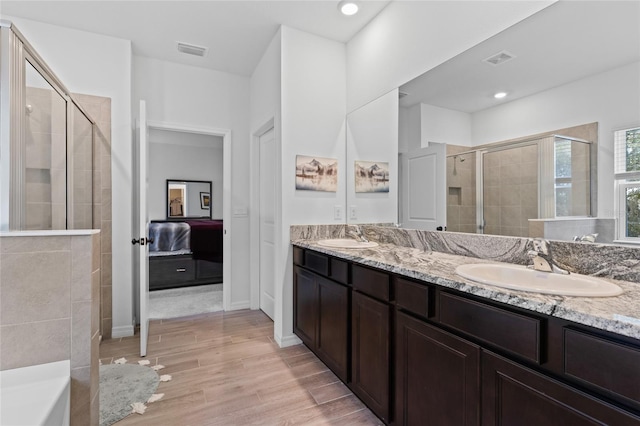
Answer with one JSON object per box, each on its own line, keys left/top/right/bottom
{"left": 395, "top": 312, "right": 480, "bottom": 426}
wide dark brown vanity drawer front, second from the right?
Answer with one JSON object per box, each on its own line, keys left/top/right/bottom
{"left": 438, "top": 292, "right": 542, "bottom": 363}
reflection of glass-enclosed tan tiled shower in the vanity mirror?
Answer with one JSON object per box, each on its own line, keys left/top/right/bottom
{"left": 447, "top": 135, "right": 592, "bottom": 237}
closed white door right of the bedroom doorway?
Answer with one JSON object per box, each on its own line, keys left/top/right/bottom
{"left": 259, "top": 128, "right": 276, "bottom": 319}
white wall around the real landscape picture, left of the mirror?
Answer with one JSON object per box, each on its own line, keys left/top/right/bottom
{"left": 275, "top": 27, "right": 346, "bottom": 344}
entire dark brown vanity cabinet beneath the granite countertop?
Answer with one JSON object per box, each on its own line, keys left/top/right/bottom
{"left": 294, "top": 248, "right": 640, "bottom": 426}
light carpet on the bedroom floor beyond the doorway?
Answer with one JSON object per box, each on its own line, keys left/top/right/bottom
{"left": 149, "top": 284, "right": 222, "bottom": 319}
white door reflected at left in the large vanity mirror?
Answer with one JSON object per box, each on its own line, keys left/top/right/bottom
{"left": 400, "top": 143, "right": 447, "bottom": 231}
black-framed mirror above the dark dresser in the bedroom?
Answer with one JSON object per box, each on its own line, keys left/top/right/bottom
{"left": 166, "top": 179, "right": 212, "bottom": 220}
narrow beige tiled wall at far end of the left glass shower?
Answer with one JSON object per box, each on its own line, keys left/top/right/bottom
{"left": 74, "top": 95, "right": 113, "bottom": 339}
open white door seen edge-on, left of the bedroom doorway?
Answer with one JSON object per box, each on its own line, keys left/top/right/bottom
{"left": 134, "top": 101, "right": 149, "bottom": 356}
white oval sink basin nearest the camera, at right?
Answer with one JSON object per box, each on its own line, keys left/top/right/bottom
{"left": 456, "top": 263, "right": 622, "bottom": 297}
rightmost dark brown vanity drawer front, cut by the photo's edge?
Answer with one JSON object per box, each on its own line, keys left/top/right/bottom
{"left": 564, "top": 328, "right": 640, "bottom": 403}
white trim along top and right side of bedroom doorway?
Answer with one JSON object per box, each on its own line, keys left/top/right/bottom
{"left": 147, "top": 120, "right": 233, "bottom": 311}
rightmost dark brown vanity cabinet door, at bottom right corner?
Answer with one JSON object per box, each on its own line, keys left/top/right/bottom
{"left": 482, "top": 351, "right": 640, "bottom": 426}
